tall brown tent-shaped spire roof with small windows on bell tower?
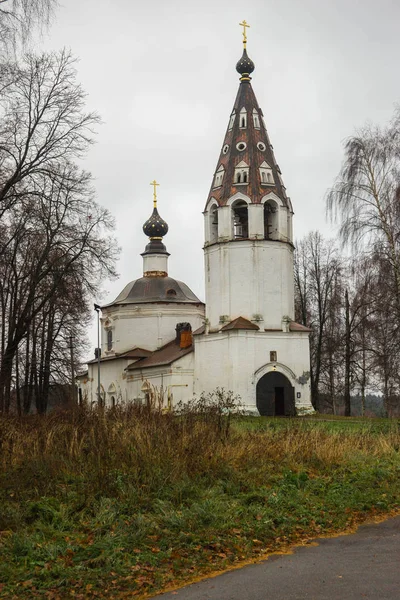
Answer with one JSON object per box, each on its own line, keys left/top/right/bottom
{"left": 207, "top": 48, "right": 290, "bottom": 208}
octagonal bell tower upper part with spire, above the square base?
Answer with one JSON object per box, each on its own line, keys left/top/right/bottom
{"left": 204, "top": 21, "right": 294, "bottom": 331}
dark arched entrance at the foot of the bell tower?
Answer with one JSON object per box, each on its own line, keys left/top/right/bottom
{"left": 256, "top": 371, "right": 296, "bottom": 417}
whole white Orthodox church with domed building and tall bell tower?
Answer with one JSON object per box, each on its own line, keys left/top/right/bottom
{"left": 77, "top": 21, "right": 312, "bottom": 416}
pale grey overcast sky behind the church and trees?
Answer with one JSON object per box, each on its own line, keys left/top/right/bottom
{"left": 39, "top": 0, "right": 400, "bottom": 354}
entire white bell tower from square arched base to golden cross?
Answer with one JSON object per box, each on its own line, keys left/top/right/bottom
{"left": 195, "top": 21, "right": 312, "bottom": 415}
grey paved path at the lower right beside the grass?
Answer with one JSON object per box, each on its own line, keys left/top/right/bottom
{"left": 157, "top": 517, "right": 400, "bottom": 600}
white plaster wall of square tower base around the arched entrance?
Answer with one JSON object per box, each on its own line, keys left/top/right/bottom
{"left": 194, "top": 330, "right": 312, "bottom": 412}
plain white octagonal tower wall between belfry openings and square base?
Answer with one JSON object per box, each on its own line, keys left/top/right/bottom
{"left": 204, "top": 240, "right": 294, "bottom": 330}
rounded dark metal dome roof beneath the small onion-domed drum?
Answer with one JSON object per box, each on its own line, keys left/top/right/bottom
{"left": 103, "top": 276, "right": 203, "bottom": 308}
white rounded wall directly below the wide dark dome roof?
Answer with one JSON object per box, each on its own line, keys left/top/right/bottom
{"left": 101, "top": 303, "right": 205, "bottom": 356}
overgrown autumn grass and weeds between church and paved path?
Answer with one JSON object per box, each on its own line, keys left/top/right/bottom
{"left": 0, "top": 408, "right": 400, "bottom": 599}
